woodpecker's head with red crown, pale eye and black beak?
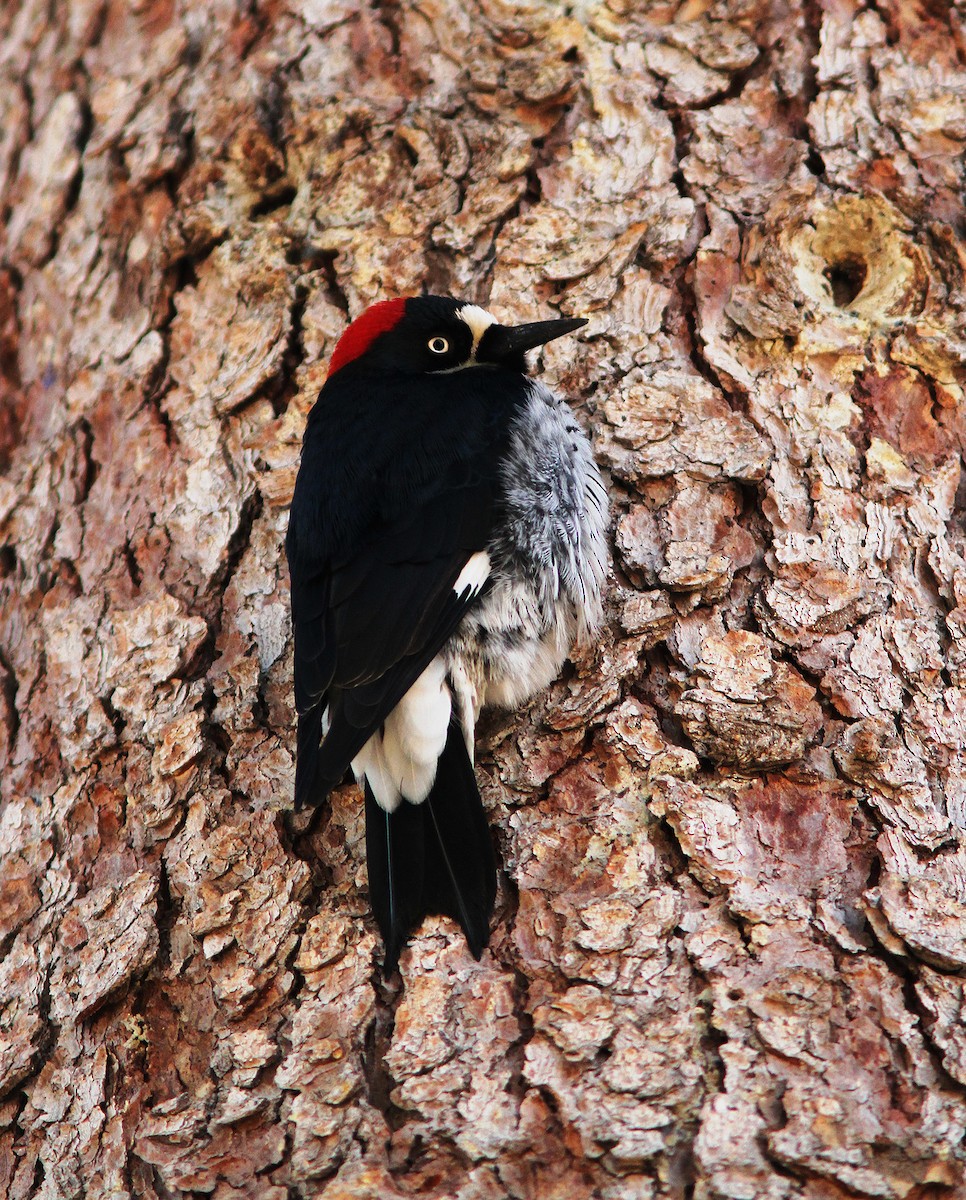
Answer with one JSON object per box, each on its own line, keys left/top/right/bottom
{"left": 329, "top": 296, "right": 587, "bottom": 378}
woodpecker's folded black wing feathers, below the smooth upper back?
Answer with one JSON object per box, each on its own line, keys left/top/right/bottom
{"left": 292, "top": 470, "right": 494, "bottom": 806}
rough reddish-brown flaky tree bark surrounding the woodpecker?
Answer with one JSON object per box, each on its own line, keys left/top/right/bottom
{"left": 0, "top": 0, "right": 966, "bottom": 1200}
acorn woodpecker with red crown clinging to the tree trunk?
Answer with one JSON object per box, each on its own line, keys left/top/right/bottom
{"left": 286, "top": 295, "right": 607, "bottom": 974}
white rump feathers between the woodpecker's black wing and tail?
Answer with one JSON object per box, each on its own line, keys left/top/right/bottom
{"left": 352, "top": 658, "right": 452, "bottom": 812}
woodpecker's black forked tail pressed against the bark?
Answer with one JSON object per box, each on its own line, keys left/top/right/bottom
{"left": 366, "top": 724, "right": 497, "bottom": 974}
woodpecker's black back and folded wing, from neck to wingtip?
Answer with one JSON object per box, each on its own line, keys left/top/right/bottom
{"left": 286, "top": 360, "right": 529, "bottom": 803}
